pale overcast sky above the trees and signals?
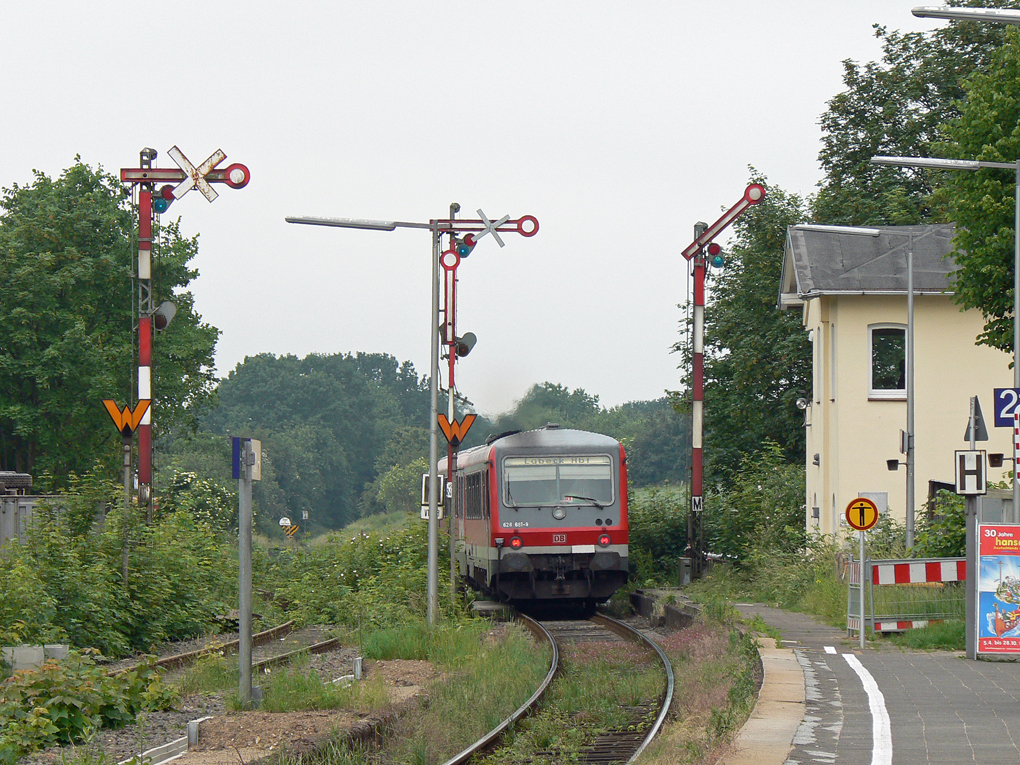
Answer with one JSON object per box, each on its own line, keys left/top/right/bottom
{"left": 0, "top": 0, "right": 946, "bottom": 415}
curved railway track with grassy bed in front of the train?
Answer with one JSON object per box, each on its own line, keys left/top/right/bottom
{"left": 444, "top": 615, "right": 673, "bottom": 765}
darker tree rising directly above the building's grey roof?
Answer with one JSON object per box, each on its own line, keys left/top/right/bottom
{"left": 812, "top": 0, "right": 1020, "bottom": 225}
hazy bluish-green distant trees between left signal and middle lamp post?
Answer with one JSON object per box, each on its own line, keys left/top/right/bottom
{"left": 205, "top": 353, "right": 428, "bottom": 528}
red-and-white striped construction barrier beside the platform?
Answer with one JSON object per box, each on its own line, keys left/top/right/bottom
{"left": 847, "top": 558, "right": 967, "bottom": 634}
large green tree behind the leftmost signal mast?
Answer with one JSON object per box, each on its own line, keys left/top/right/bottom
{"left": 0, "top": 161, "right": 217, "bottom": 489}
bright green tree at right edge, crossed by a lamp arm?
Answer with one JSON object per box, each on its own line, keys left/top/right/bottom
{"left": 938, "top": 29, "right": 1020, "bottom": 351}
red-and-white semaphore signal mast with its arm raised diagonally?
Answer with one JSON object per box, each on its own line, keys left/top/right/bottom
{"left": 680, "top": 184, "right": 765, "bottom": 578}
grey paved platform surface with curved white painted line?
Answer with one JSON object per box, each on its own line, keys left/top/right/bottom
{"left": 723, "top": 604, "right": 1020, "bottom": 765}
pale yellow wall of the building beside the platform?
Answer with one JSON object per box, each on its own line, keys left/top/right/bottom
{"left": 804, "top": 295, "right": 1013, "bottom": 534}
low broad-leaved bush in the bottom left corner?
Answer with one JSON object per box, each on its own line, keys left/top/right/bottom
{"left": 0, "top": 651, "right": 176, "bottom": 763}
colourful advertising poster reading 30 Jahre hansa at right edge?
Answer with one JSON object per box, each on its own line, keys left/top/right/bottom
{"left": 977, "top": 523, "right": 1020, "bottom": 654}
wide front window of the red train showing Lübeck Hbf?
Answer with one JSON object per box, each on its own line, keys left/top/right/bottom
{"left": 503, "top": 455, "right": 613, "bottom": 507}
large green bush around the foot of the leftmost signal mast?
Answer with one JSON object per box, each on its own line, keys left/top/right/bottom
{"left": 6, "top": 500, "right": 237, "bottom": 656}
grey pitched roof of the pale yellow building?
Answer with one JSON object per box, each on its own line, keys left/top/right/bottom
{"left": 779, "top": 223, "right": 957, "bottom": 307}
